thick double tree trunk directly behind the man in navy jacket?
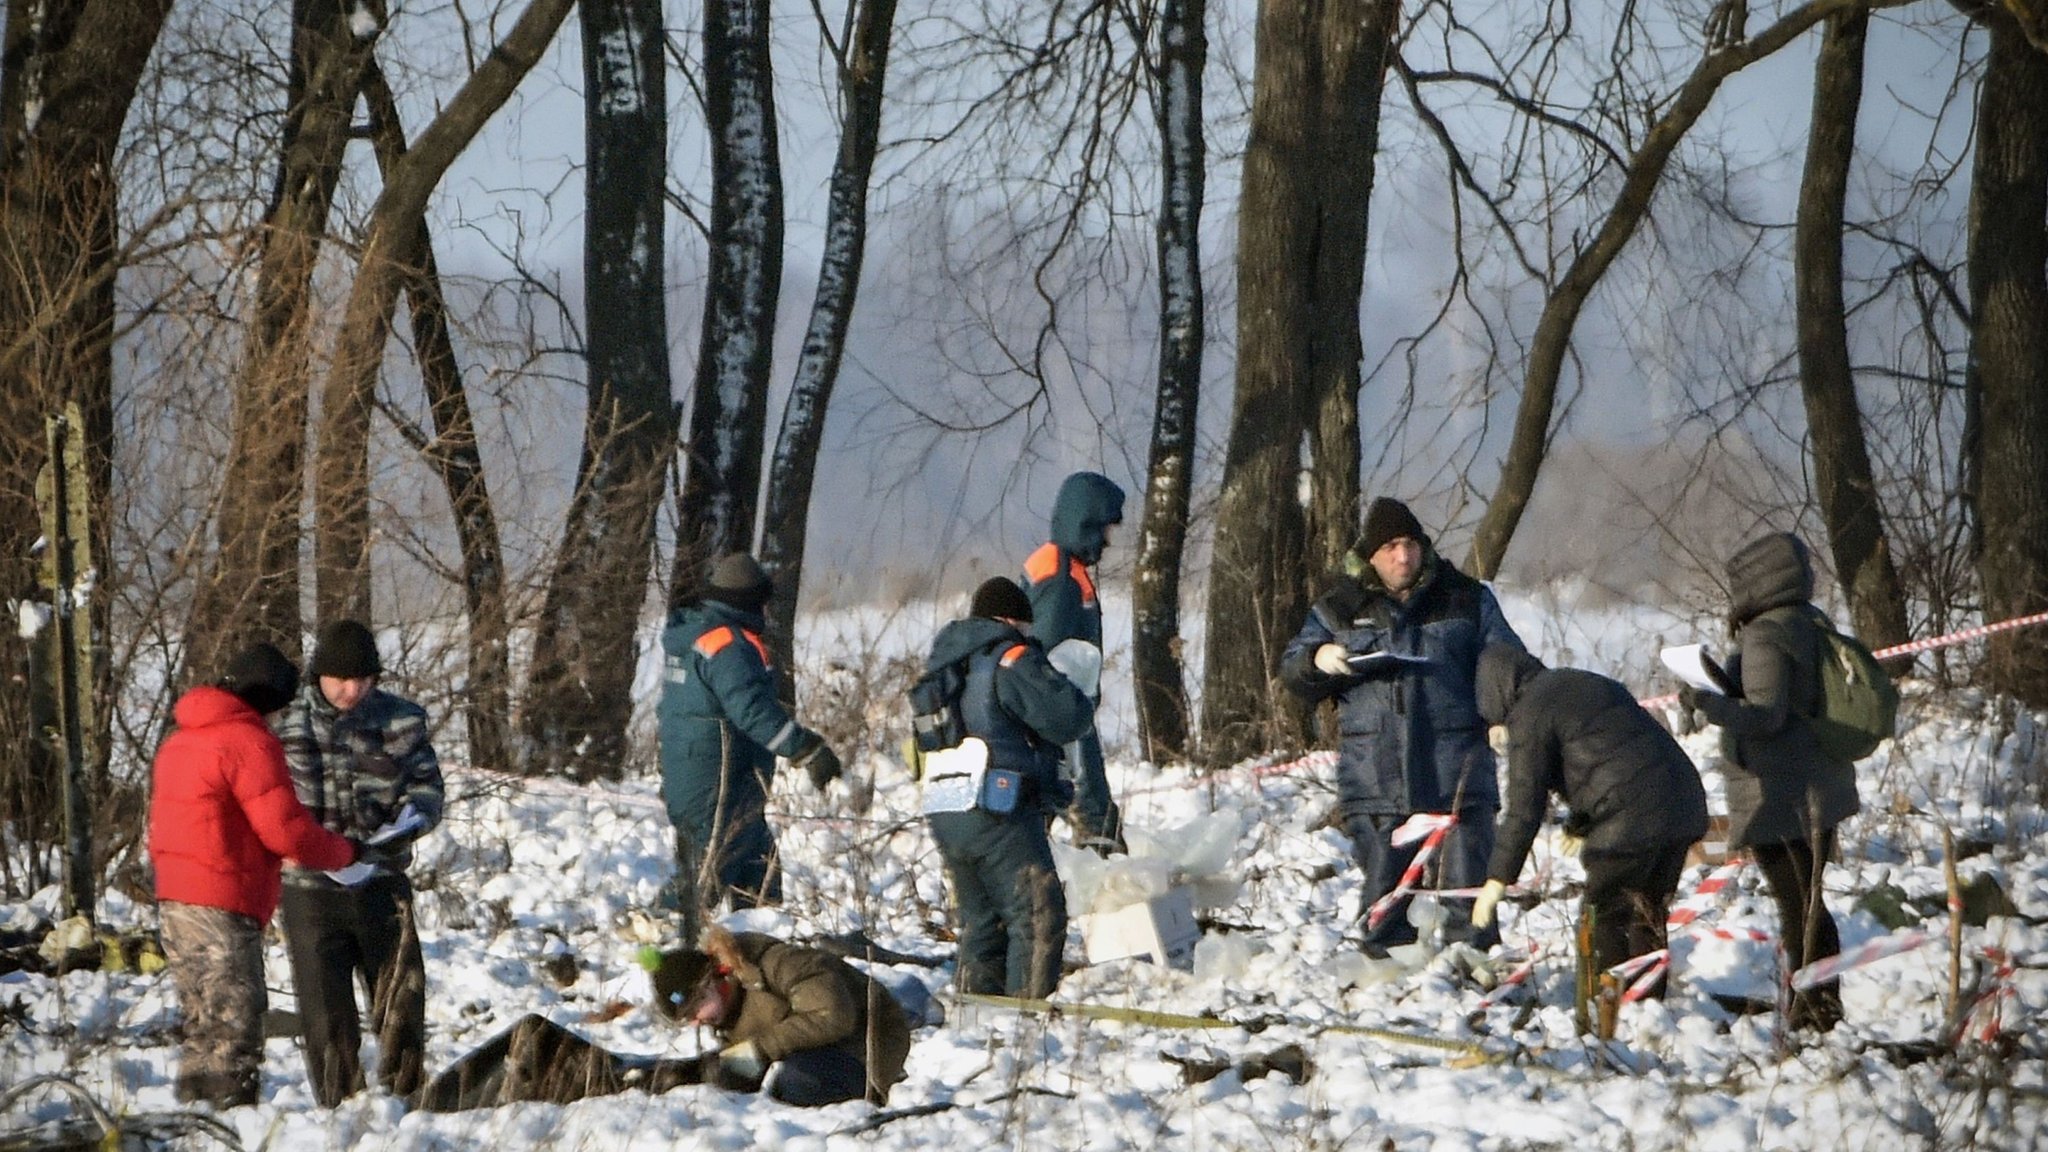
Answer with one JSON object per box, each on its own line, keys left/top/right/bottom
{"left": 1202, "top": 0, "right": 1399, "bottom": 758}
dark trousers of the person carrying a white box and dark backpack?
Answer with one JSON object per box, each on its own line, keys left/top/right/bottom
{"left": 930, "top": 810, "right": 1067, "bottom": 998}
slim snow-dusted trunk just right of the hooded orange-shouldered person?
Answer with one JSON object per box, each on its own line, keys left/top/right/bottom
{"left": 1130, "top": 0, "right": 1208, "bottom": 760}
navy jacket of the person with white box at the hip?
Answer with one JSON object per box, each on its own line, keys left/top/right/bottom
{"left": 926, "top": 617, "right": 1094, "bottom": 808}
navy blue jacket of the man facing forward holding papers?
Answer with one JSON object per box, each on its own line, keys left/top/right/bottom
{"left": 1280, "top": 549, "right": 1522, "bottom": 818}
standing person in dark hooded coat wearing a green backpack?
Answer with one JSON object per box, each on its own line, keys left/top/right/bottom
{"left": 1679, "top": 533, "right": 1860, "bottom": 1031}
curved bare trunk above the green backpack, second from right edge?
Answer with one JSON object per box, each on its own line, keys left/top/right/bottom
{"left": 1792, "top": 8, "right": 1909, "bottom": 660}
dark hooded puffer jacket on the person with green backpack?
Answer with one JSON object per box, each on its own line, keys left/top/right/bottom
{"left": 1700, "top": 533, "right": 1860, "bottom": 849}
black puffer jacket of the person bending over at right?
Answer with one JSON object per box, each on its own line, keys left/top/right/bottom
{"left": 1479, "top": 646, "right": 1706, "bottom": 883}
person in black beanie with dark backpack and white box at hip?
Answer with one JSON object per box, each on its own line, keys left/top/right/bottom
{"left": 924, "top": 576, "right": 1094, "bottom": 998}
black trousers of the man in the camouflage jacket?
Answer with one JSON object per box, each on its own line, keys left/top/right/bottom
{"left": 279, "top": 875, "right": 426, "bottom": 1107}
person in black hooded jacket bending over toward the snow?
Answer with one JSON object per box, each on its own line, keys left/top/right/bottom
{"left": 1473, "top": 644, "right": 1706, "bottom": 996}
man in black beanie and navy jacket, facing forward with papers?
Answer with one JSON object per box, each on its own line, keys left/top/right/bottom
{"left": 1280, "top": 496, "right": 1522, "bottom": 955}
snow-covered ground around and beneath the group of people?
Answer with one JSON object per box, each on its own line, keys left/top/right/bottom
{"left": 0, "top": 586, "right": 2048, "bottom": 1152}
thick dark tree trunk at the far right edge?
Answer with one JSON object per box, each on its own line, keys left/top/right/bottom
{"left": 1970, "top": 6, "right": 2048, "bottom": 707}
